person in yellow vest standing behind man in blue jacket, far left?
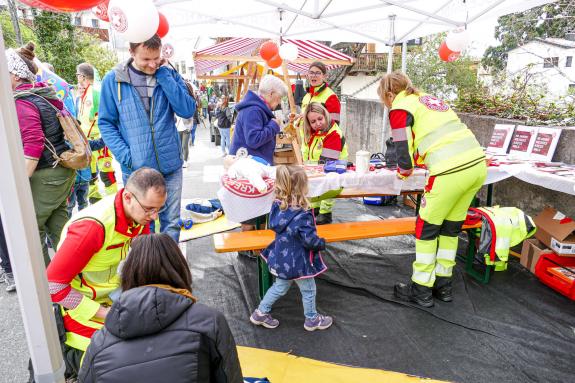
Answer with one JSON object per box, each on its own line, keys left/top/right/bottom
{"left": 76, "top": 63, "right": 118, "bottom": 204}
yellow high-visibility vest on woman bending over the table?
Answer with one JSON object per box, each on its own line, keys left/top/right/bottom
{"left": 390, "top": 91, "right": 485, "bottom": 175}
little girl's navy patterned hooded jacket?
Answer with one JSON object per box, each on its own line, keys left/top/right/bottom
{"left": 261, "top": 201, "right": 327, "bottom": 279}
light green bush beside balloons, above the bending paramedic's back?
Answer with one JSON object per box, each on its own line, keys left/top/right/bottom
{"left": 407, "top": 34, "right": 479, "bottom": 100}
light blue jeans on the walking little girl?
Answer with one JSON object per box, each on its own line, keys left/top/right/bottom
{"left": 258, "top": 278, "right": 317, "bottom": 318}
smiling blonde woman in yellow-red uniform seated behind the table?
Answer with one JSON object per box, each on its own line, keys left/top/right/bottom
{"left": 301, "top": 102, "right": 347, "bottom": 225}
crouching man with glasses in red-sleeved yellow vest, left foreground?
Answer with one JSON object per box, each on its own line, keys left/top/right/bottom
{"left": 46, "top": 168, "right": 166, "bottom": 356}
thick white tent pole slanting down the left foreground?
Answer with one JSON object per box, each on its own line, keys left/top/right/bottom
{"left": 0, "top": 31, "right": 66, "bottom": 383}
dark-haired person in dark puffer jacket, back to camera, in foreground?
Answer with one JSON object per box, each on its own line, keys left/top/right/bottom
{"left": 79, "top": 234, "right": 243, "bottom": 383}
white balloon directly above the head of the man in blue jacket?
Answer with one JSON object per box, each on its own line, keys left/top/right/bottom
{"left": 108, "top": 0, "right": 160, "bottom": 43}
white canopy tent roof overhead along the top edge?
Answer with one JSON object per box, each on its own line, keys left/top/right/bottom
{"left": 155, "top": 0, "right": 553, "bottom": 45}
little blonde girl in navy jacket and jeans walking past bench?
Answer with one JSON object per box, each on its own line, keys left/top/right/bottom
{"left": 250, "top": 165, "right": 333, "bottom": 331}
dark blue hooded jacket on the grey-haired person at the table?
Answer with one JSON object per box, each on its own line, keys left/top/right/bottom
{"left": 230, "top": 90, "right": 280, "bottom": 164}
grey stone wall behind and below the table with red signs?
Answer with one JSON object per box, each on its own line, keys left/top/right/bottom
{"left": 345, "top": 98, "right": 575, "bottom": 217}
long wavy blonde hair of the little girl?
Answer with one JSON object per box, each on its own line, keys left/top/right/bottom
{"left": 275, "top": 165, "right": 310, "bottom": 210}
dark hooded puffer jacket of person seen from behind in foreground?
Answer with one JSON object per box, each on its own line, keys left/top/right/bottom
{"left": 79, "top": 286, "right": 243, "bottom": 383}
